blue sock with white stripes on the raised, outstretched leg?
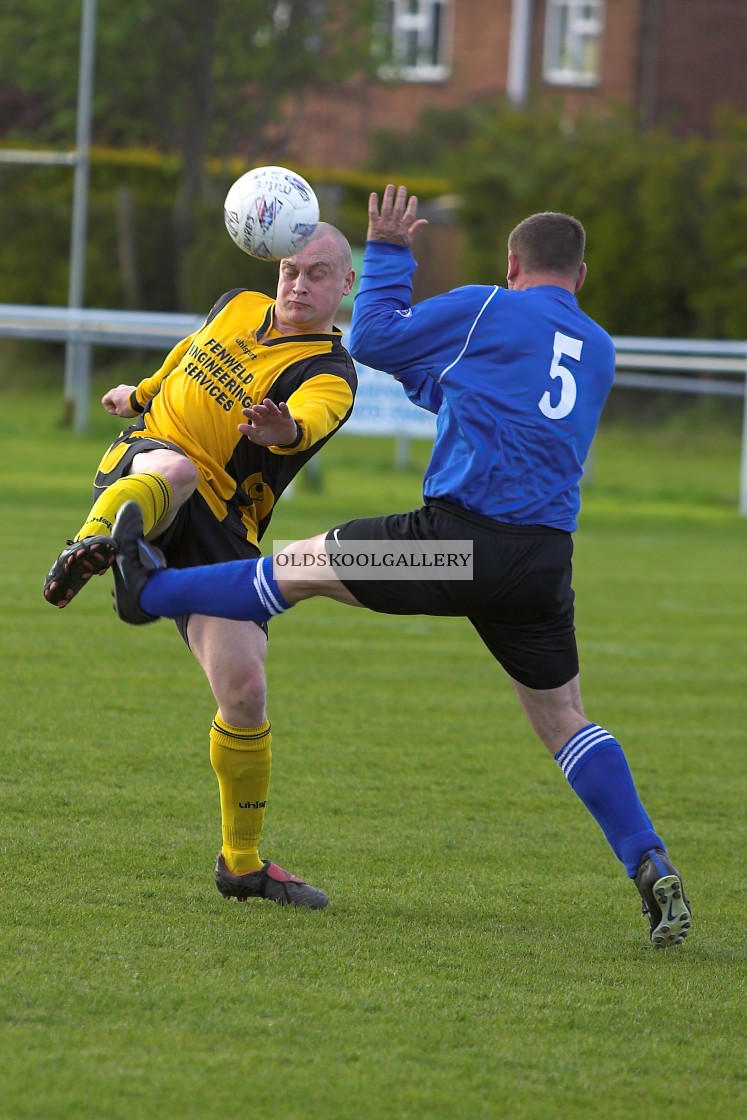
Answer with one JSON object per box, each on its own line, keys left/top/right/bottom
{"left": 140, "top": 557, "right": 291, "bottom": 623}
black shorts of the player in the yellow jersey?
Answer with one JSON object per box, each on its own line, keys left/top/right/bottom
{"left": 93, "top": 435, "right": 268, "bottom": 645}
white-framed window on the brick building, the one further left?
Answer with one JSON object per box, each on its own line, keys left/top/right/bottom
{"left": 377, "top": 0, "right": 451, "bottom": 82}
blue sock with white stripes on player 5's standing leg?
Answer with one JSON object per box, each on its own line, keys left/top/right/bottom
{"left": 554, "top": 724, "right": 664, "bottom": 879}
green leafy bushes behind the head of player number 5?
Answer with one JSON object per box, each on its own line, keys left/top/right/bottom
{"left": 377, "top": 102, "right": 747, "bottom": 339}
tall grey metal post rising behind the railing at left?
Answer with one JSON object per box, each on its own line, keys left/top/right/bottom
{"left": 64, "top": 0, "right": 96, "bottom": 432}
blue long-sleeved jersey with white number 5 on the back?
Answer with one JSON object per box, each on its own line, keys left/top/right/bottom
{"left": 349, "top": 242, "right": 615, "bottom": 532}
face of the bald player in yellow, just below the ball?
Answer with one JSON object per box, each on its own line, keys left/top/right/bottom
{"left": 276, "top": 236, "right": 354, "bottom": 334}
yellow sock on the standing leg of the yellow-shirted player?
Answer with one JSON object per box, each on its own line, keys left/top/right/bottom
{"left": 211, "top": 713, "right": 272, "bottom": 875}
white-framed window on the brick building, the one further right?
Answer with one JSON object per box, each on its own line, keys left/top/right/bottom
{"left": 542, "top": 0, "right": 605, "bottom": 85}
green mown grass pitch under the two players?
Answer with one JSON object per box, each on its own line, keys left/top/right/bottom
{"left": 0, "top": 386, "right": 747, "bottom": 1120}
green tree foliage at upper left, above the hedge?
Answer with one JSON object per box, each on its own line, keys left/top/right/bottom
{"left": 0, "top": 0, "right": 373, "bottom": 302}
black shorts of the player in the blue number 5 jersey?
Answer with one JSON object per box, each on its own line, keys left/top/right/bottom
{"left": 327, "top": 501, "right": 578, "bottom": 689}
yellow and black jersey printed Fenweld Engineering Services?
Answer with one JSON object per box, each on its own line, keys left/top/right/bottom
{"left": 122, "top": 288, "right": 357, "bottom": 543}
